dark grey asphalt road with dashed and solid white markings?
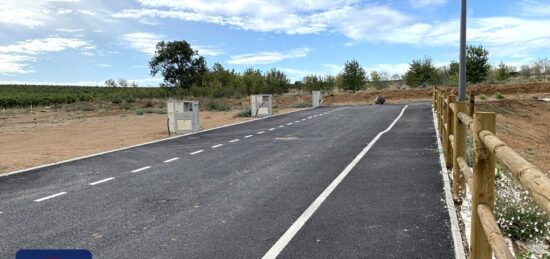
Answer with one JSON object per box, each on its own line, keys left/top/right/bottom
{"left": 0, "top": 104, "right": 454, "bottom": 258}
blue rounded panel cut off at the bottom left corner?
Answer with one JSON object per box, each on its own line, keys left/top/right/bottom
{"left": 15, "top": 249, "right": 92, "bottom": 259}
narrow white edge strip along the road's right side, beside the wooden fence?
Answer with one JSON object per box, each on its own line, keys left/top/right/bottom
{"left": 432, "top": 110, "right": 466, "bottom": 259}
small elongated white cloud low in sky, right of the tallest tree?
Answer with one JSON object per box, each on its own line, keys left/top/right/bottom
{"left": 227, "top": 48, "right": 309, "bottom": 65}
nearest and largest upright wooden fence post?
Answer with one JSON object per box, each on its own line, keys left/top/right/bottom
{"left": 470, "top": 112, "right": 496, "bottom": 259}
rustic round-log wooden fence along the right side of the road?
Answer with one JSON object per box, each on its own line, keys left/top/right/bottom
{"left": 433, "top": 89, "right": 550, "bottom": 259}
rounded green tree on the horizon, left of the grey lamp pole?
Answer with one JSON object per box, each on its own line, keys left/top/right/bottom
{"left": 404, "top": 57, "right": 439, "bottom": 87}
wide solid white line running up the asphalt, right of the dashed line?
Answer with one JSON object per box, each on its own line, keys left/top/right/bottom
{"left": 262, "top": 105, "right": 409, "bottom": 259}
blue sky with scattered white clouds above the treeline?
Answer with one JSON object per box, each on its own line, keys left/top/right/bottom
{"left": 0, "top": 0, "right": 550, "bottom": 86}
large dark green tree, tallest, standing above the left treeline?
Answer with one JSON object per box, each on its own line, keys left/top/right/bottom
{"left": 149, "top": 40, "right": 208, "bottom": 88}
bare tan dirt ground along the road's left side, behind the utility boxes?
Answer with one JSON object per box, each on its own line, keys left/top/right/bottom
{"left": 0, "top": 108, "right": 296, "bottom": 174}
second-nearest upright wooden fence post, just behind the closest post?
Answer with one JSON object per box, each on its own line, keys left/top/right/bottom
{"left": 453, "top": 102, "right": 468, "bottom": 204}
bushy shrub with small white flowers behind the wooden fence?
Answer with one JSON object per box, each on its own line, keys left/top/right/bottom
{"left": 495, "top": 167, "right": 550, "bottom": 241}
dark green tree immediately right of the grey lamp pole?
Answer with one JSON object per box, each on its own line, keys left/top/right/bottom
{"left": 466, "top": 45, "right": 491, "bottom": 84}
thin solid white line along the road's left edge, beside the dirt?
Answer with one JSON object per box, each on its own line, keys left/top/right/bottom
{"left": 0, "top": 107, "right": 315, "bottom": 177}
